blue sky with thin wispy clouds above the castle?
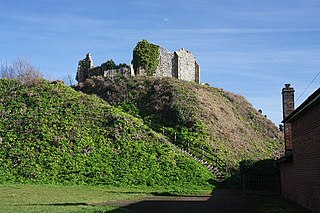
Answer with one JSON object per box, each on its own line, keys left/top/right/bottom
{"left": 0, "top": 0, "right": 320, "bottom": 125}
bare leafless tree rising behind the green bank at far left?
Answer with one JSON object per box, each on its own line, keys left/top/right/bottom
{"left": 0, "top": 58, "right": 42, "bottom": 83}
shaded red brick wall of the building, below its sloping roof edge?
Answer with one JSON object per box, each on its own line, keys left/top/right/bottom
{"left": 281, "top": 101, "right": 320, "bottom": 212}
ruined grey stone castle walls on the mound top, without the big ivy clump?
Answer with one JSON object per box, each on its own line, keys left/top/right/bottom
{"left": 76, "top": 40, "right": 200, "bottom": 83}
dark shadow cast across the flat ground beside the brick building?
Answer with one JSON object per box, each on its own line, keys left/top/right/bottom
{"left": 102, "top": 173, "right": 309, "bottom": 213}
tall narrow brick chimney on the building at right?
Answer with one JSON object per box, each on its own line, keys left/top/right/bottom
{"left": 282, "top": 84, "right": 294, "bottom": 155}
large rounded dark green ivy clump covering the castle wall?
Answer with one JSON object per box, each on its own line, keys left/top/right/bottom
{"left": 132, "top": 39, "right": 160, "bottom": 76}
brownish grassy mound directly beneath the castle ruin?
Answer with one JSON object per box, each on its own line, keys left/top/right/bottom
{"left": 75, "top": 77, "right": 283, "bottom": 167}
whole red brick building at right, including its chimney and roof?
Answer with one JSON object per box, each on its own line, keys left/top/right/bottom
{"left": 278, "top": 84, "right": 320, "bottom": 212}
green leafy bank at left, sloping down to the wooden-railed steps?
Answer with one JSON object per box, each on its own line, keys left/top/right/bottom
{"left": 0, "top": 79, "right": 213, "bottom": 188}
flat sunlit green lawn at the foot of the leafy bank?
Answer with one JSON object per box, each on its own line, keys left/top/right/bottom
{"left": 0, "top": 184, "right": 212, "bottom": 212}
